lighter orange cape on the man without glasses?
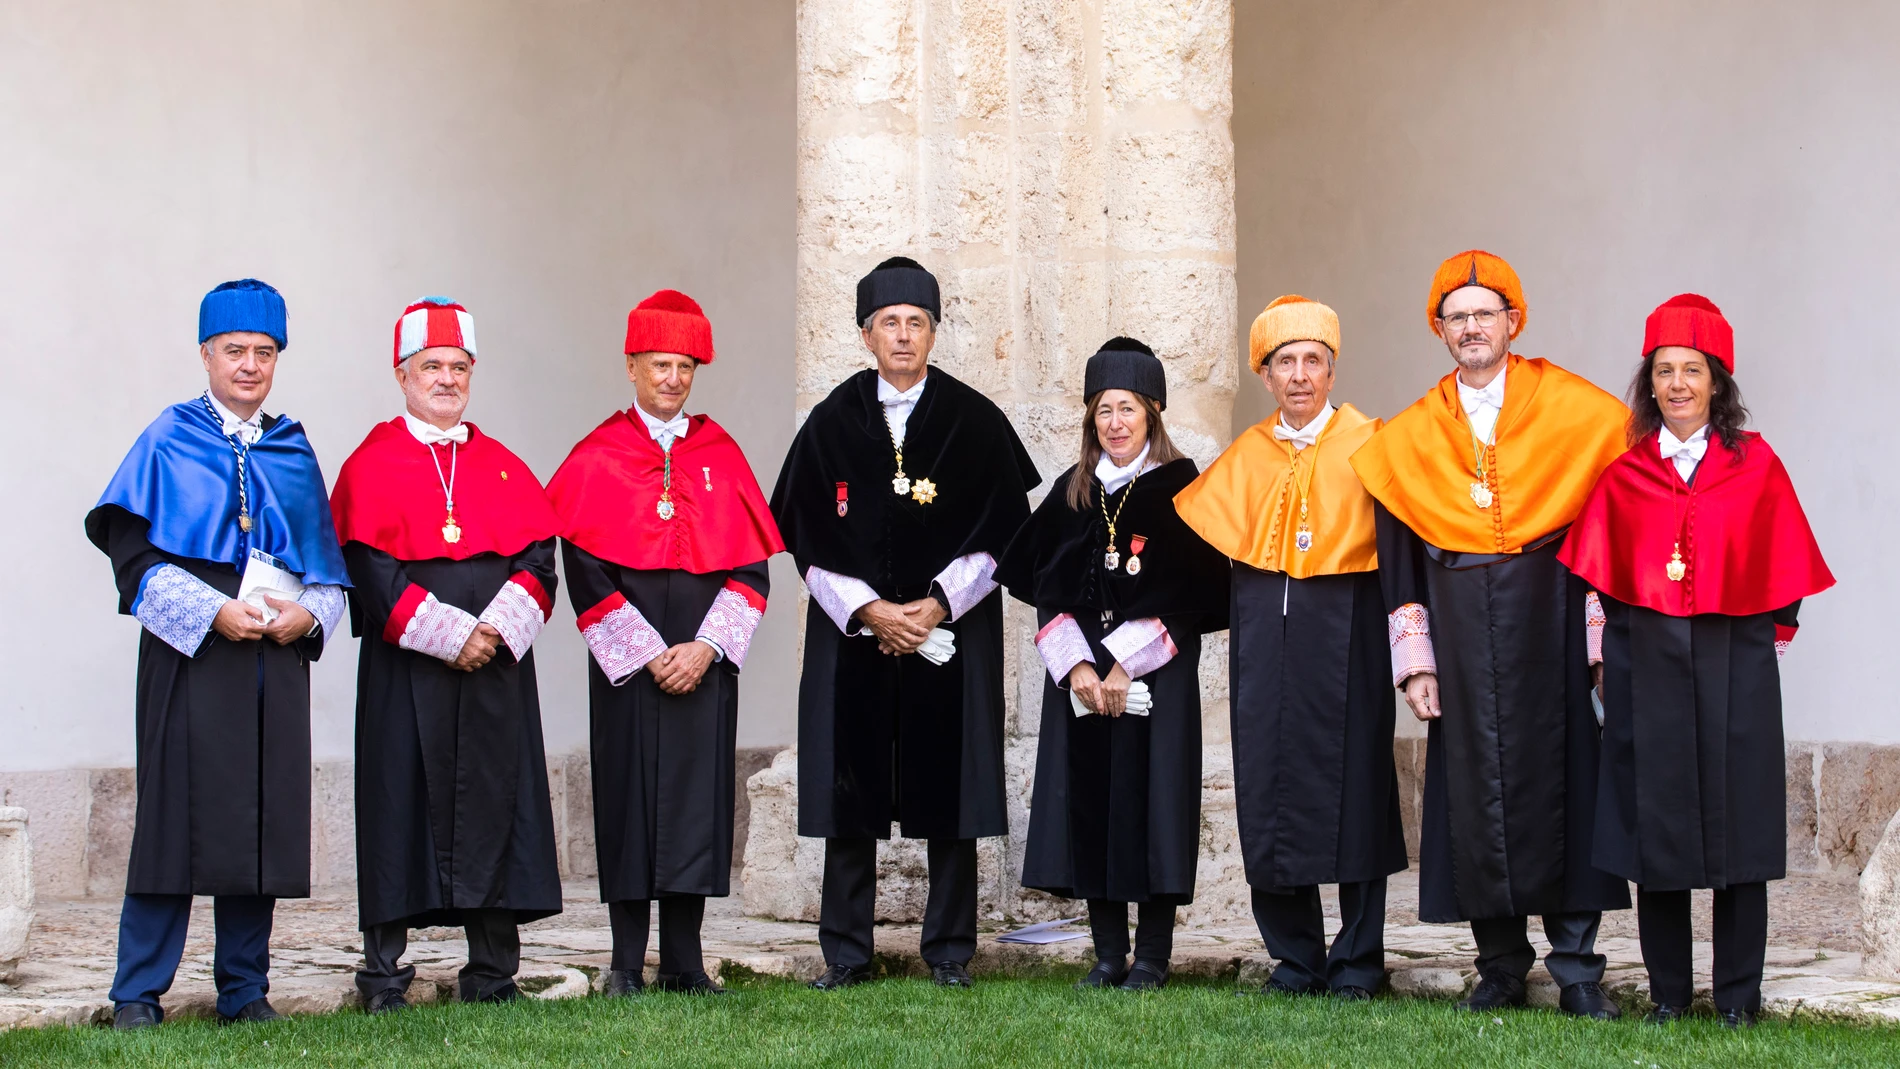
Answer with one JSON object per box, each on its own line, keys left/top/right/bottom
{"left": 1174, "top": 404, "right": 1379, "bottom": 579}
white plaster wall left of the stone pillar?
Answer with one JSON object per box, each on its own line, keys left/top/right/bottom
{"left": 0, "top": 0, "right": 796, "bottom": 769}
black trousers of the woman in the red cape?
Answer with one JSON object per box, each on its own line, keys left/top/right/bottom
{"left": 1636, "top": 883, "right": 1769, "bottom": 1014}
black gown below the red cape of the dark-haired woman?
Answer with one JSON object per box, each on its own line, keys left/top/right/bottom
{"left": 1592, "top": 594, "right": 1801, "bottom": 891}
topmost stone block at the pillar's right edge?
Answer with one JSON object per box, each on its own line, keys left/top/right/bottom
{"left": 1102, "top": 0, "right": 1233, "bottom": 122}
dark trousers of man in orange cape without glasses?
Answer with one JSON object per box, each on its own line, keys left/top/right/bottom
{"left": 1254, "top": 877, "right": 1385, "bottom": 991}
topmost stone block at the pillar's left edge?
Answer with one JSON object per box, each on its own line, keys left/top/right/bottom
{"left": 798, "top": 0, "right": 922, "bottom": 123}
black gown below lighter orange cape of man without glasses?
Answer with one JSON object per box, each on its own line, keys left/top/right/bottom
{"left": 1229, "top": 562, "right": 1406, "bottom": 892}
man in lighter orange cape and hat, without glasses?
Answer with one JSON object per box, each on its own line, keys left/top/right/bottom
{"left": 1174, "top": 296, "right": 1406, "bottom": 999}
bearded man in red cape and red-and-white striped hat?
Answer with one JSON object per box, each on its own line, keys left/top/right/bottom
{"left": 331, "top": 296, "right": 561, "bottom": 1014}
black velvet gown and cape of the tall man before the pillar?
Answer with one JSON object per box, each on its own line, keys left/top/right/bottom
{"left": 771, "top": 368, "right": 1041, "bottom": 839}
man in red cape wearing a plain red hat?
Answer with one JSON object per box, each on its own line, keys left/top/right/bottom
{"left": 547, "top": 291, "right": 785, "bottom": 995}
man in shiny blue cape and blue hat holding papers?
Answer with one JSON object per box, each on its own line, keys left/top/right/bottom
{"left": 86, "top": 279, "right": 350, "bottom": 1029}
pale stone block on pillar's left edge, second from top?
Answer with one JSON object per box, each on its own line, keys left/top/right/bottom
{"left": 798, "top": 131, "right": 920, "bottom": 256}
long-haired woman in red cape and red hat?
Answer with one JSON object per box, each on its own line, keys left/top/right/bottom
{"left": 1560, "top": 294, "right": 1834, "bottom": 1027}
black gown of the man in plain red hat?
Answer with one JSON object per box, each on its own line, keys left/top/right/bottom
{"left": 561, "top": 541, "right": 771, "bottom": 902}
